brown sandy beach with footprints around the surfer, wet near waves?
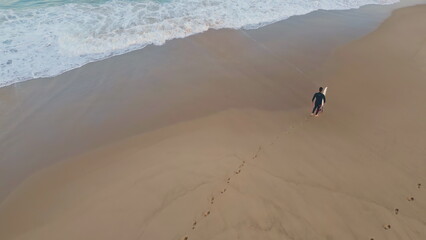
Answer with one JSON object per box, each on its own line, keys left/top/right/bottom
{"left": 0, "top": 1, "right": 426, "bottom": 240}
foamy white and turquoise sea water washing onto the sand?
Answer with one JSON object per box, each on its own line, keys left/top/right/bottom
{"left": 0, "top": 0, "right": 397, "bottom": 87}
